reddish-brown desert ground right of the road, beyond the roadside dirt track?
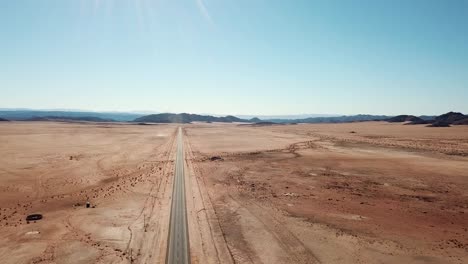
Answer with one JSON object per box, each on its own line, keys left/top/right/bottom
{"left": 185, "top": 122, "right": 468, "bottom": 263}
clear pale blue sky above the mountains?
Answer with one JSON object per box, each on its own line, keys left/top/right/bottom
{"left": 0, "top": 0, "right": 468, "bottom": 115}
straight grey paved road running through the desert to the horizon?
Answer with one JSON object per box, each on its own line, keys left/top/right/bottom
{"left": 166, "top": 128, "right": 190, "bottom": 264}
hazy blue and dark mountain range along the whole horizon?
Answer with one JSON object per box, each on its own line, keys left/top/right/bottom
{"left": 0, "top": 109, "right": 468, "bottom": 126}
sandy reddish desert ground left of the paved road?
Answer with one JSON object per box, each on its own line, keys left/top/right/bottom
{"left": 0, "top": 122, "right": 179, "bottom": 263}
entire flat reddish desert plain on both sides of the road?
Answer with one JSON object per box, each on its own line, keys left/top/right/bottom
{"left": 0, "top": 122, "right": 468, "bottom": 263}
